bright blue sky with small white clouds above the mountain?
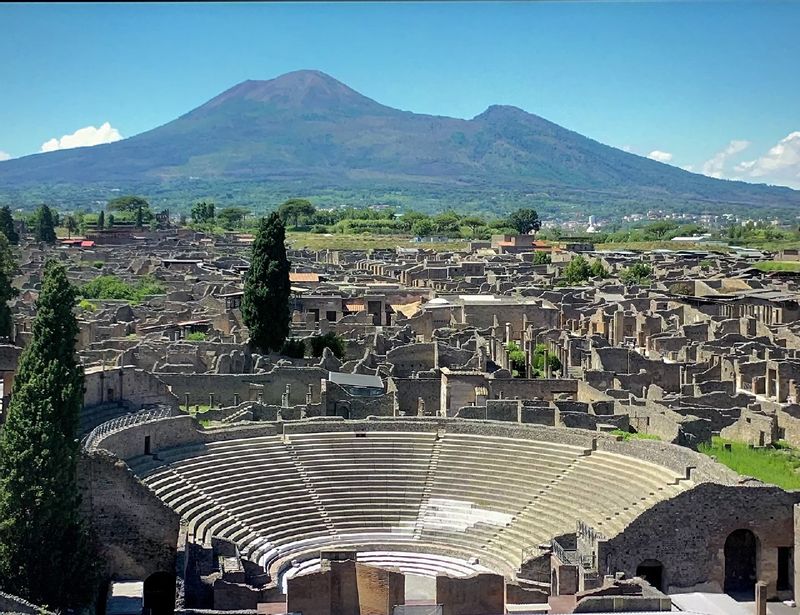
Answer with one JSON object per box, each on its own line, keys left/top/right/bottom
{"left": 0, "top": 0, "right": 800, "bottom": 187}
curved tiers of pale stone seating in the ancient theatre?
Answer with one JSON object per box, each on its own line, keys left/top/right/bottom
{"left": 131, "top": 430, "right": 692, "bottom": 576}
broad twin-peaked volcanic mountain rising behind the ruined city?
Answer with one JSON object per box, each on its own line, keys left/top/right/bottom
{"left": 0, "top": 71, "right": 800, "bottom": 214}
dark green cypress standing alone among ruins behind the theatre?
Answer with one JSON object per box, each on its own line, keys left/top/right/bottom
{"left": 242, "top": 212, "right": 291, "bottom": 352}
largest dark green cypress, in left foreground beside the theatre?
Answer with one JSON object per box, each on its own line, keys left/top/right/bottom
{"left": 0, "top": 261, "right": 94, "bottom": 608}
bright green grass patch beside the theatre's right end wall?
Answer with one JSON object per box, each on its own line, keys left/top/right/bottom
{"left": 698, "top": 436, "right": 800, "bottom": 489}
